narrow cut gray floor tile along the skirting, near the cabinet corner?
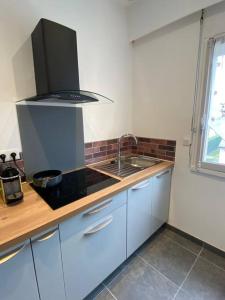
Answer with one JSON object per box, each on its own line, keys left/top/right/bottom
{"left": 163, "top": 228, "right": 202, "bottom": 254}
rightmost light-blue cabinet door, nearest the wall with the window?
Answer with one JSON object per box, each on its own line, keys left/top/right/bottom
{"left": 152, "top": 170, "right": 171, "bottom": 232}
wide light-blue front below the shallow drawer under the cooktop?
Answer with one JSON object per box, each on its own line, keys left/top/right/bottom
{"left": 60, "top": 205, "right": 126, "bottom": 300}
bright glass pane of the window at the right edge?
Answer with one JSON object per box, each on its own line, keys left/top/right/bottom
{"left": 202, "top": 39, "right": 225, "bottom": 164}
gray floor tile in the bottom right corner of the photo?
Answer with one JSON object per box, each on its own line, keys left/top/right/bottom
{"left": 181, "top": 258, "right": 225, "bottom": 300}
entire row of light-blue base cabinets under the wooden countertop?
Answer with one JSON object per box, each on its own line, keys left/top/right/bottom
{"left": 0, "top": 170, "right": 171, "bottom": 300}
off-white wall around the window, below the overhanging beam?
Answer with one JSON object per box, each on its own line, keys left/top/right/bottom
{"left": 134, "top": 3, "right": 225, "bottom": 250}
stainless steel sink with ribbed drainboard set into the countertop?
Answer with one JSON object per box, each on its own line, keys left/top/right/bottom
{"left": 96, "top": 156, "right": 161, "bottom": 177}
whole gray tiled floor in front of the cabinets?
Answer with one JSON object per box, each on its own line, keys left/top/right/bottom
{"left": 87, "top": 228, "right": 225, "bottom": 300}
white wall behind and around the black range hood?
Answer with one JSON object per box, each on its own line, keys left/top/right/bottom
{"left": 0, "top": 0, "right": 132, "bottom": 149}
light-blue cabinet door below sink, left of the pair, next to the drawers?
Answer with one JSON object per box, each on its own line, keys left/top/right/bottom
{"left": 127, "top": 179, "right": 152, "bottom": 256}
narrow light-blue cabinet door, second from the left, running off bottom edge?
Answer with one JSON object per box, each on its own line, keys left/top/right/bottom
{"left": 32, "top": 228, "right": 65, "bottom": 300}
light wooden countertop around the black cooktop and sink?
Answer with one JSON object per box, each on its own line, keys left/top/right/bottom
{"left": 0, "top": 161, "right": 174, "bottom": 251}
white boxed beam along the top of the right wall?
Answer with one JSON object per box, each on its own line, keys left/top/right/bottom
{"left": 128, "top": 0, "right": 222, "bottom": 41}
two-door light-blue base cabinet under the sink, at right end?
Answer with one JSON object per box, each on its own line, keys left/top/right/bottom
{"left": 127, "top": 170, "right": 171, "bottom": 257}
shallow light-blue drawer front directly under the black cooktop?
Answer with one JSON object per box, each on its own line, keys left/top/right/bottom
{"left": 59, "top": 191, "right": 127, "bottom": 238}
